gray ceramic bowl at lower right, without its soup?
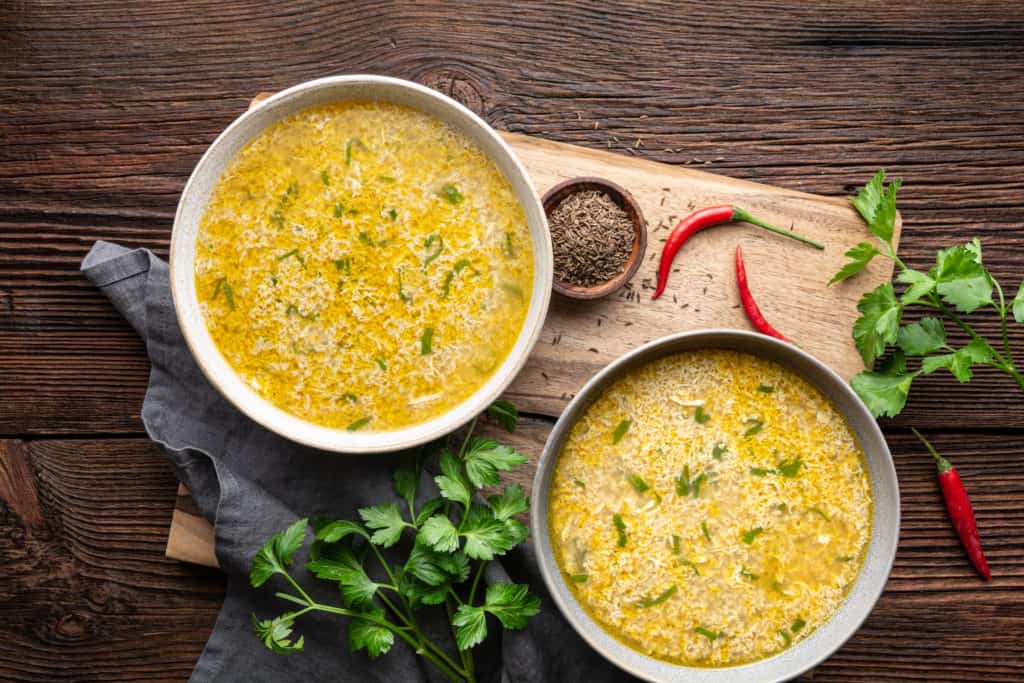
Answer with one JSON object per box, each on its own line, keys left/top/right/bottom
{"left": 530, "top": 330, "right": 900, "bottom": 683}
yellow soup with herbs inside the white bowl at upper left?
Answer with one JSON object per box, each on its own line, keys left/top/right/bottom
{"left": 196, "top": 101, "right": 534, "bottom": 430}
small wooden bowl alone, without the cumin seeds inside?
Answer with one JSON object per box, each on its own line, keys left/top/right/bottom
{"left": 541, "top": 177, "right": 647, "bottom": 299}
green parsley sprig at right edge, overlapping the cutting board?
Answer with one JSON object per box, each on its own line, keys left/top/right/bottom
{"left": 829, "top": 170, "right": 1024, "bottom": 417}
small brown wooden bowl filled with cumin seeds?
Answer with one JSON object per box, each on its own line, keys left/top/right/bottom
{"left": 543, "top": 177, "right": 647, "bottom": 299}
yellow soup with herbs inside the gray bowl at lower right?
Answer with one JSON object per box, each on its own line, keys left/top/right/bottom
{"left": 549, "top": 350, "right": 871, "bottom": 667}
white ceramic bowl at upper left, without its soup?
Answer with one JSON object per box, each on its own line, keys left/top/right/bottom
{"left": 171, "top": 76, "right": 553, "bottom": 453}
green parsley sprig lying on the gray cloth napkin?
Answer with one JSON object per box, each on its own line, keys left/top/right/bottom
{"left": 250, "top": 401, "right": 540, "bottom": 683}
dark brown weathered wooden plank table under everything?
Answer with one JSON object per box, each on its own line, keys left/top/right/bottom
{"left": 0, "top": 0, "right": 1024, "bottom": 681}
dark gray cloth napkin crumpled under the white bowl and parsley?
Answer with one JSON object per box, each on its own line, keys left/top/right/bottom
{"left": 82, "top": 242, "right": 628, "bottom": 683}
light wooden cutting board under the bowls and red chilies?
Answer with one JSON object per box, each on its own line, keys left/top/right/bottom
{"left": 159, "top": 95, "right": 902, "bottom": 566}
